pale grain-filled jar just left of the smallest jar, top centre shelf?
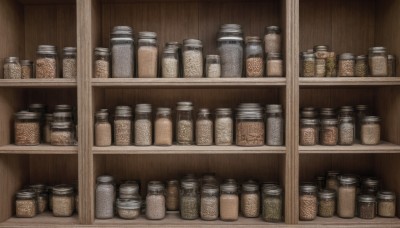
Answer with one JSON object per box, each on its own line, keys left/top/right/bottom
{"left": 182, "top": 39, "right": 203, "bottom": 78}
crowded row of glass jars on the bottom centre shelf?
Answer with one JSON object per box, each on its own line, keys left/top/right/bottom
{"left": 95, "top": 174, "right": 283, "bottom": 222}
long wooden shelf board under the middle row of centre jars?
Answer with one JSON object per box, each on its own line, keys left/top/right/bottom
{"left": 93, "top": 145, "right": 286, "bottom": 154}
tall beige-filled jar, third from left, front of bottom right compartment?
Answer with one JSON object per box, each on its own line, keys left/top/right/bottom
{"left": 337, "top": 176, "right": 357, "bottom": 218}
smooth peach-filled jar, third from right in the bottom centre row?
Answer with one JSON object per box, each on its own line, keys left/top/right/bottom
{"left": 219, "top": 183, "right": 239, "bottom": 221}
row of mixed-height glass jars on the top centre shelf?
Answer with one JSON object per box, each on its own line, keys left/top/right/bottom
{"left": 94, "top": 24, "right": 284, "bottom": 78}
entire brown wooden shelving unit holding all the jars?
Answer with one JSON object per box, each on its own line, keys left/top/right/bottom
{"left": 0, "top": 0, "right": 400, "bottom": 228}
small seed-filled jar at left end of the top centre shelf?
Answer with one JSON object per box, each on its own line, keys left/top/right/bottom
{"left": 94, "top": 47, "right": 110, "bottom": 78}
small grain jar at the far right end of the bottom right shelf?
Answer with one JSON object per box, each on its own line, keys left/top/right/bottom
{"left": 376, "top": 191, "right": 396, "bottom": 218}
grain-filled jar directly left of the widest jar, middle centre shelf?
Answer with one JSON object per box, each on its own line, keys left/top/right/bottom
{"left": 215, "top": 108, "right": 233, "bottom": 146}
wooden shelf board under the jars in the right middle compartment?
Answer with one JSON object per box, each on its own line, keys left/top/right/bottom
{"left": 299, "top": 141, "right": 400, "bottom": 154}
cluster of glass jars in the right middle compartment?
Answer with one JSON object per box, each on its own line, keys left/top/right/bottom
{"left": 300, "top": 105, "right": 381, "bottom": 146}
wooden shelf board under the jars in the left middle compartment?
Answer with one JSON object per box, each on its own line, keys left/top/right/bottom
{"left": 0, "top": 144, "right": 78, "bottom": 154}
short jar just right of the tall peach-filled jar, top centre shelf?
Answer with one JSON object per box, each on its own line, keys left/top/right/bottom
{"left": 161, "top": 47, "right": 179, "bottom": 78}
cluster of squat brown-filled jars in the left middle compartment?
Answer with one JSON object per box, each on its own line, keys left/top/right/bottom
{"left": 14, "top": 104, "right": 77, "bottom": 146}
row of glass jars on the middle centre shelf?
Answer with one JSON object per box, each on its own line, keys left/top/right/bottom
{"left": 94, "top": 102, "right": 284, "bottom": 146}
